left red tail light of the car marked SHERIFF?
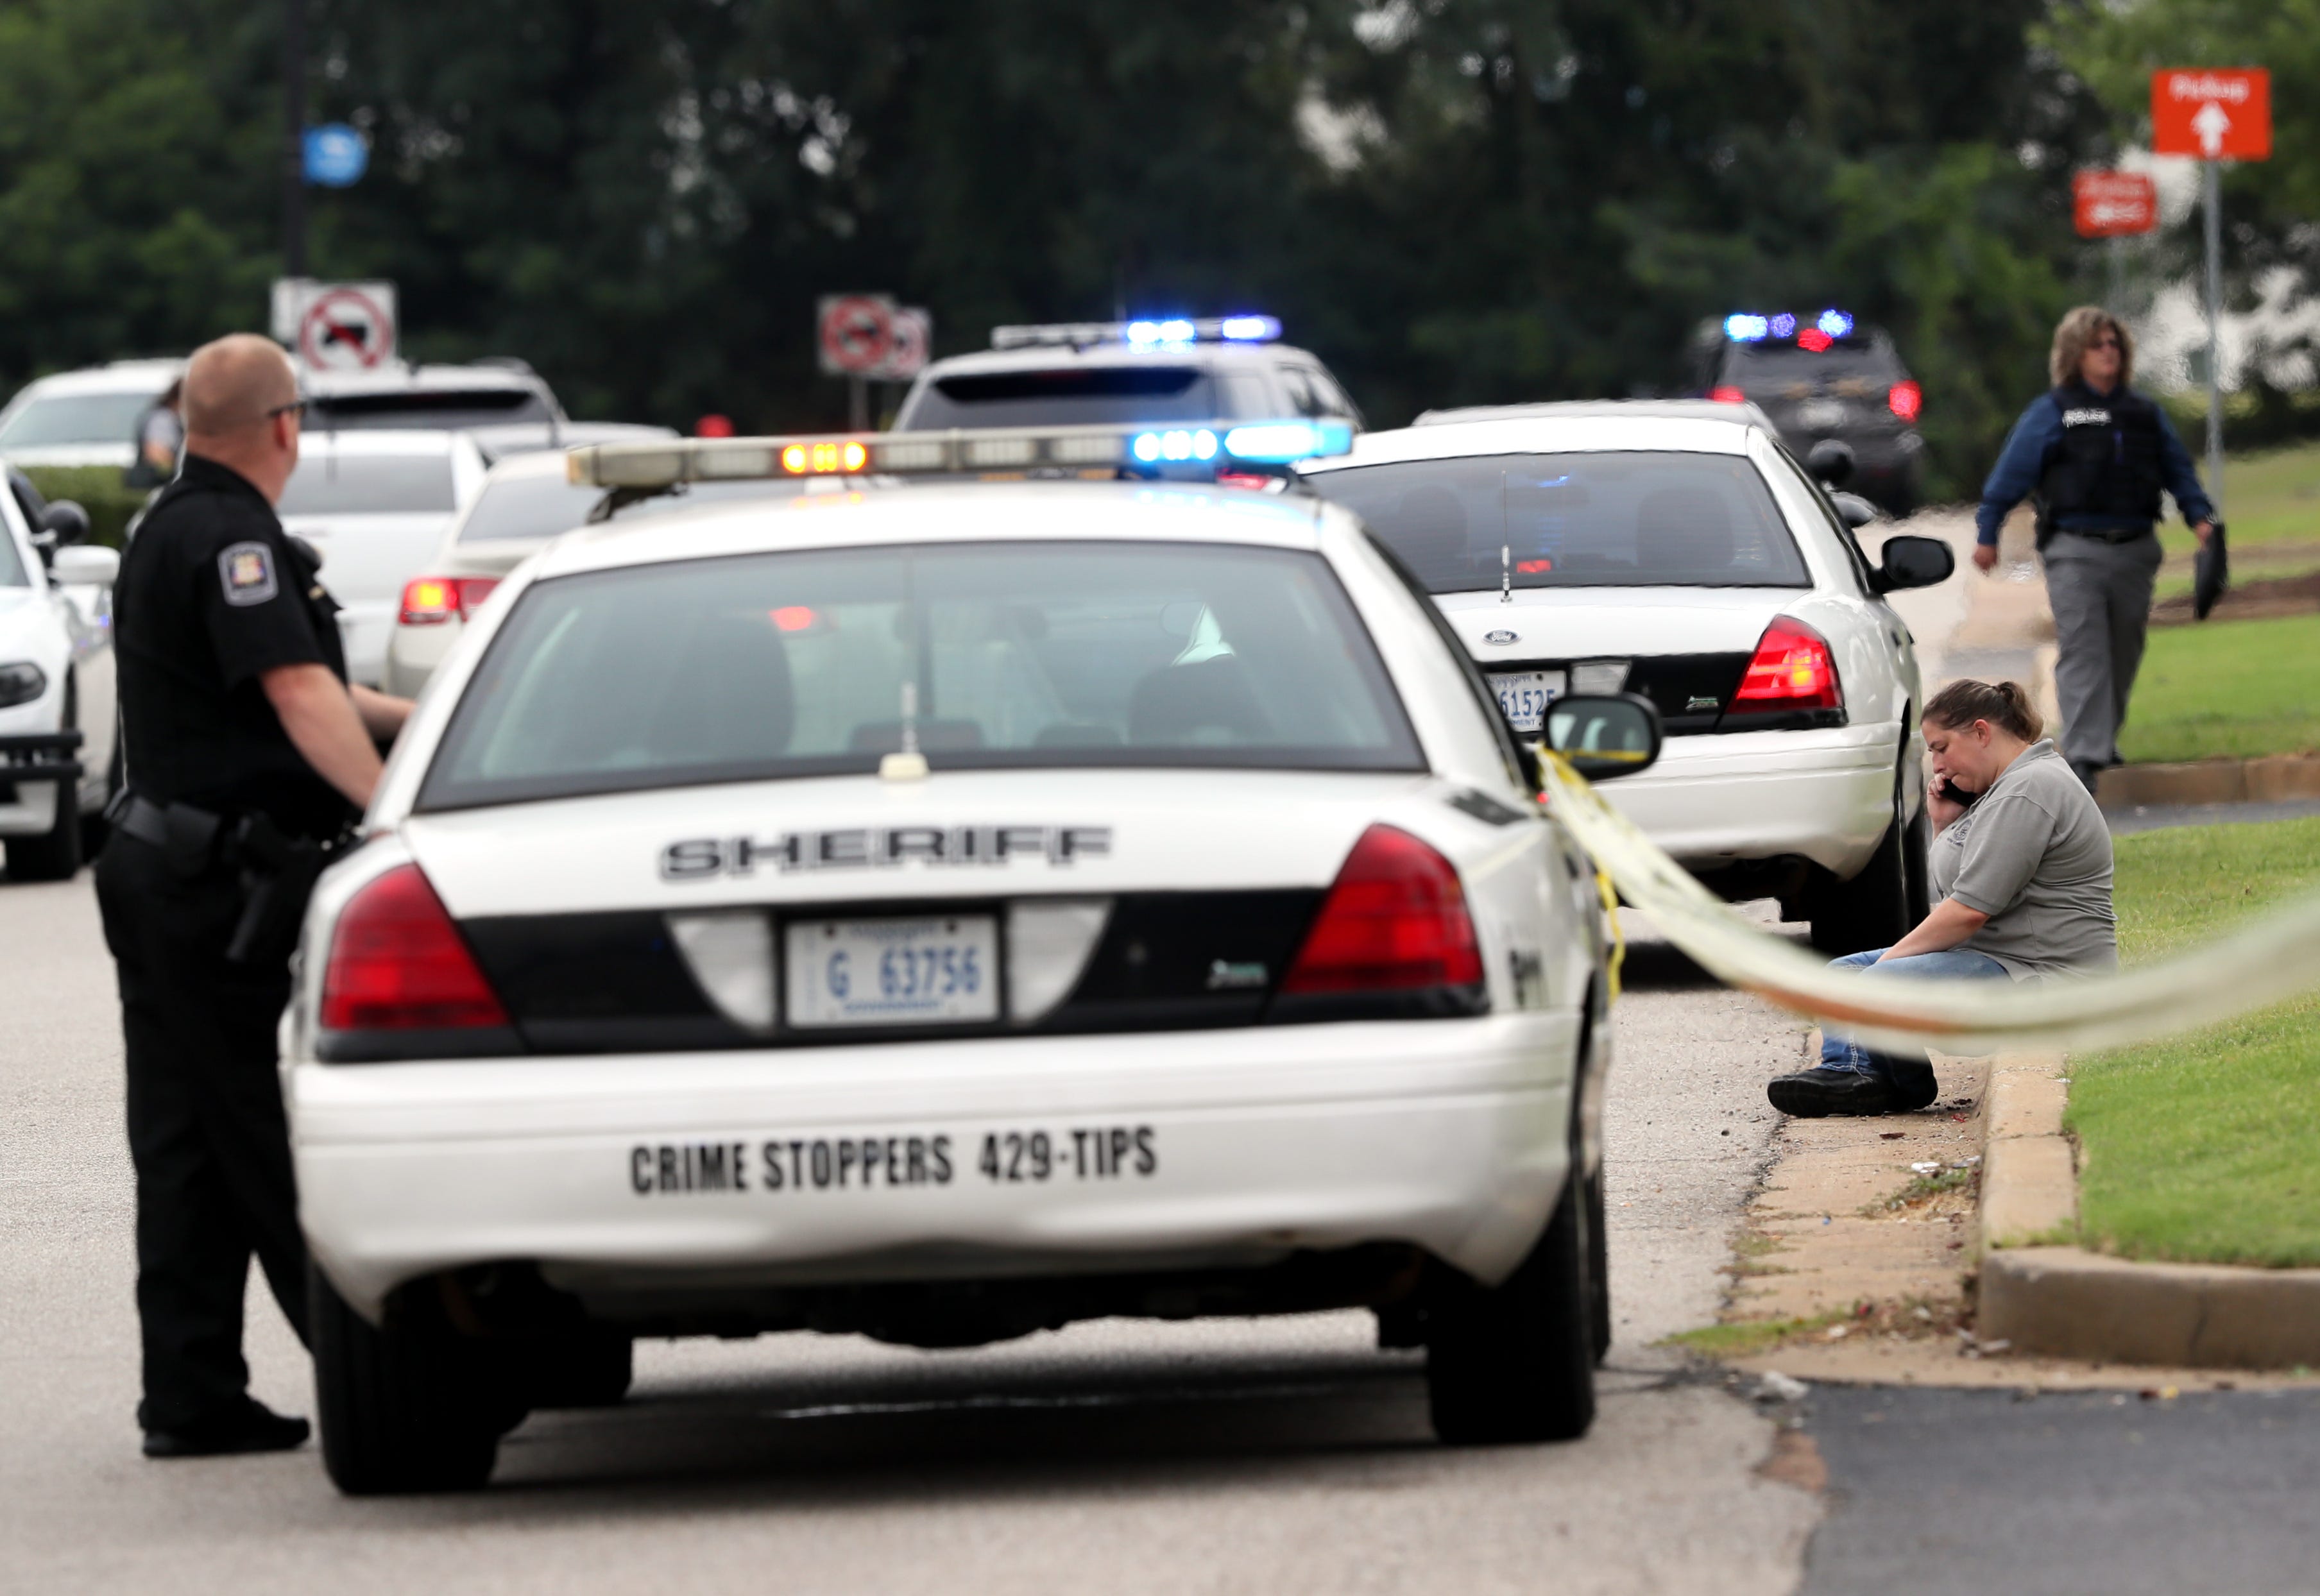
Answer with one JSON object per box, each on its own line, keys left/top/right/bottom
{"left": 323, "top": 865, "right": 508, "bottom": 1030}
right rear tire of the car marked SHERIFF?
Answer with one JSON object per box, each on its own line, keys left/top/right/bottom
{"left": 1427, "top": 1167, "right": 1596, "bottom": 1445}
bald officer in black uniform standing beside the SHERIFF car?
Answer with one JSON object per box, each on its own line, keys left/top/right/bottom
{"left": 98, "top": 334, "right": 411, "bottom": 1457}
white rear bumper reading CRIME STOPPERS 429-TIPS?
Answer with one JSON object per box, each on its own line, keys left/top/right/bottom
{"left": 286, "top": 1012, "right": 1580, "bottom": 1313}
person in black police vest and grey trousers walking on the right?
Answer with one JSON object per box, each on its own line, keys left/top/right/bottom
{"left": 1974, "top": 304, "right": 2215, "bottom": 791}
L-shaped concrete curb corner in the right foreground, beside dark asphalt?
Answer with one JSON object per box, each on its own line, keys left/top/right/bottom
{"left": 1977, "top": 1048, "right": 2320, "bottom": 1369}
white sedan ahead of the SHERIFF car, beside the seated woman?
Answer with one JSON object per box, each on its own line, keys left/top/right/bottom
{"left": 1302, "top": 402, "right": 1954, "bottom": 953}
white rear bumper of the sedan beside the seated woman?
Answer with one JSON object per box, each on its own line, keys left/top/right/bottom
{"left": 1603, "top": 724, "right": 1900, "bottom": 879}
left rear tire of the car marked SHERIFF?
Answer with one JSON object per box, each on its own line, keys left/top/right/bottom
{"left": 306, "top": 1266, "right": 513, "bottom": 1497}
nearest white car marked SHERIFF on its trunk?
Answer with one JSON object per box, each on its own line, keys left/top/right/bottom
{"left": 283, "top": 429, "right": 1659, "bottom": 1491}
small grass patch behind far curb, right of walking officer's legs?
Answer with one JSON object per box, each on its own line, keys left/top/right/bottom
{"left": 2118, "top": 615, "right": 2320, "bottom": 763}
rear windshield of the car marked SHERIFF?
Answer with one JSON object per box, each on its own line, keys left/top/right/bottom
{"left": 420, "top": 543, "right": 1424, "bottom": 810}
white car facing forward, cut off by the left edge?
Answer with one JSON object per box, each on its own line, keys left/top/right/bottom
{"left": 0, "top": 482, "right": 121, "bottom": 881}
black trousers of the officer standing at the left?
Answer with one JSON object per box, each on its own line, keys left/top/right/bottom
{"left": 98, "top": 835, "right": 306, "bottom": 1429}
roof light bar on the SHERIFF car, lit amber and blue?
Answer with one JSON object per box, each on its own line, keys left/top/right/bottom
{"left": 564, "top": 420, "right": 1352, "bottom": 487}
